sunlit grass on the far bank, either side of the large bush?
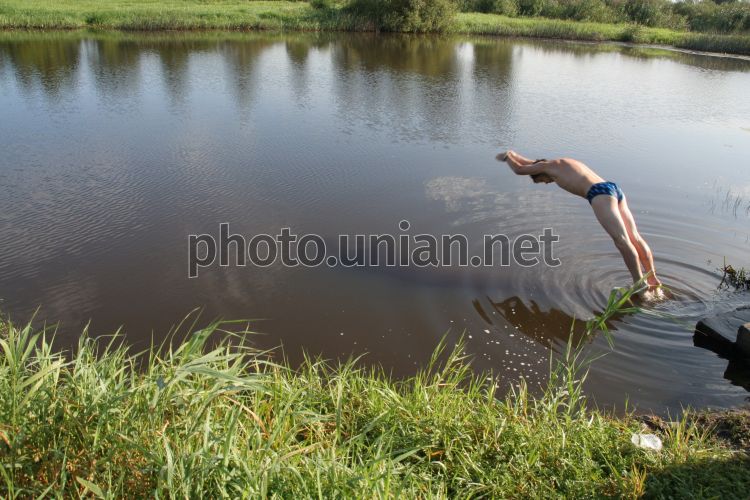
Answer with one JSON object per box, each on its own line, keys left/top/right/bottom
{"left": 0, "top": 0, "right": 750, "bottom": 55}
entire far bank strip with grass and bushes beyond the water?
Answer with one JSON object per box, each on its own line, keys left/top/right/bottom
{"left": 0, "top": 0, "right": 750, "bottom": 54}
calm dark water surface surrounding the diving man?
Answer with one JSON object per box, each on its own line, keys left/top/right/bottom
{"left": 0, "top": 34, "right": 750, "bottom": 412}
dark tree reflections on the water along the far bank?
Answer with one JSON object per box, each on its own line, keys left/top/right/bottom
{"left": 0, "top": 33, "right": 750, "bottom": 123}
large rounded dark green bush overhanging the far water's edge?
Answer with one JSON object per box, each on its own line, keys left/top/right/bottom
{"left": 347, "top": 0, "right": 458, "bottom": 33}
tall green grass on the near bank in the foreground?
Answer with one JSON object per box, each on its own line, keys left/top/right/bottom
{"left": 0, "top": 286, "right": 750, "bottom": 498}
